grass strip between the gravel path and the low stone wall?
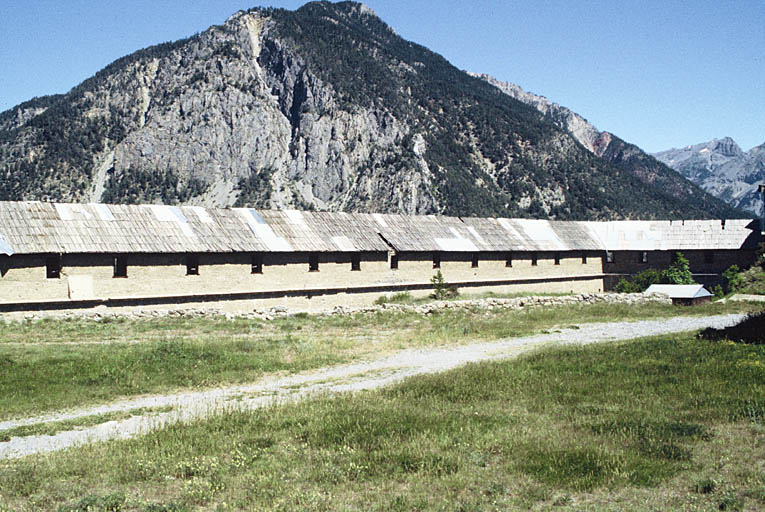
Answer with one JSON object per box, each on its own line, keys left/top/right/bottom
{"left": 0, "top": 303, "right": 758, "bottom": 419}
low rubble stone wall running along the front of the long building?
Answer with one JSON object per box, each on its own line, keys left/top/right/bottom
{"left": 0, "top": 293, "right": 672, "bottom": 321}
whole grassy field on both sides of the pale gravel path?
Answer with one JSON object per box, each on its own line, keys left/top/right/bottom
{"left": 0, "top": 304, "right": 765, "bottom": 512}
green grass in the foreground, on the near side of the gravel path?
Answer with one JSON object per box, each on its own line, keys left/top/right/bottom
{"left": 0, "top": 335, "right": 765, "bottom": 511}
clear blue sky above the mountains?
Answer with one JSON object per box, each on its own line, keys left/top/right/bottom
{"left": 0, "top": 0, "right": 765, "bottom": 151}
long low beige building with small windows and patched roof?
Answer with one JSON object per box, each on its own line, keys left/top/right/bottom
{"left": 0, "top": 202, "right": 760, "bottom": 311}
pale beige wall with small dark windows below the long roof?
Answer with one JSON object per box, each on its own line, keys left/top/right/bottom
{"left": 0, "top": 252, "right": 602, "bottom": 303}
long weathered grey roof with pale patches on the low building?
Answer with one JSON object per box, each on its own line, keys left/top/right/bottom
{"left": 0, "top": 201, "right": 759, "bottom": 254}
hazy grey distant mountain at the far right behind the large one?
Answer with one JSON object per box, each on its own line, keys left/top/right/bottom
{"left": 654, "top": 137, "right": 765, "bottom": 216}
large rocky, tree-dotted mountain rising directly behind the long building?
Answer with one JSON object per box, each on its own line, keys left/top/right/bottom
{"left": 0, "top": 2, "right": 736, "bottom": 219}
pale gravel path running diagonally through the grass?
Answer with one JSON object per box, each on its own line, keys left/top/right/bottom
{"left": 0, "top": 314, "right": 746, "bottom": 459}
